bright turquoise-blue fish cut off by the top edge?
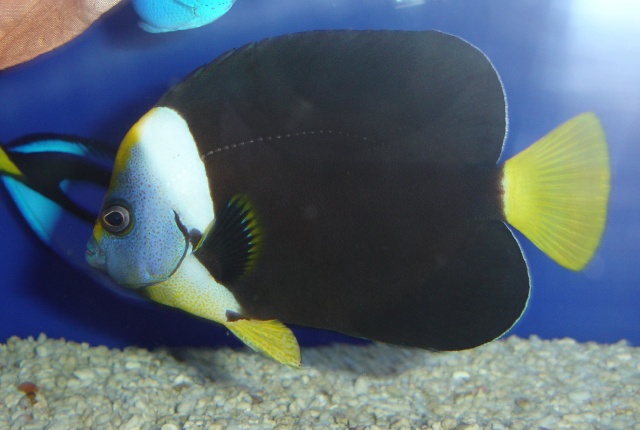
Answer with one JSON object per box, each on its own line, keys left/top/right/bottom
{"left": 132, "top": 0, "right": 235, "bottom": 33}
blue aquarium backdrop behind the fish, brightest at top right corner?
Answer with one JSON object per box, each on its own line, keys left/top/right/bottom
{"left": 0, "top": 0, "right": 640, "bottom": 348}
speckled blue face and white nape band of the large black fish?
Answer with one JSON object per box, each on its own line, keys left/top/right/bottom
{"left": 86, "top": 107, "right": 214, "bottom": 288}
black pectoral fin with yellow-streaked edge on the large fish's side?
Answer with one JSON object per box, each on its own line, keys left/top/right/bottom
{"left": 194, "top": 194, "right": 262, "bottom": 283}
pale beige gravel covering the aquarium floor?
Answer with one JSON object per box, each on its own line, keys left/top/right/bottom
{"left": 0, "top": 335, "right": 640, "bottom": 430}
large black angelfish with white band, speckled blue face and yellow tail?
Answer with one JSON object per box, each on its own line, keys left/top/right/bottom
{"left": 87, "top": 31, "right": 610, "bottom": 366}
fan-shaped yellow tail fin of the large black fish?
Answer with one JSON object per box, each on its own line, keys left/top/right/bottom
{"left": 502, "top": 112, "right": 611, "bottom": 270}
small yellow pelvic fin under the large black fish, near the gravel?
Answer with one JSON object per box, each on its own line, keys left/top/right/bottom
{"left": 224, "top": 319, "right": 300, "bottom": 367}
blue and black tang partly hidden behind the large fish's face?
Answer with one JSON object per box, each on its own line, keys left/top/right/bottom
{"left": 0, "top": 134, "right": 138, "bottom": 297}
